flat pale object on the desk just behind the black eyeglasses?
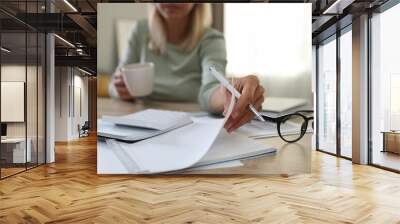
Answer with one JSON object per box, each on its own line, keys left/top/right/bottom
{"left": 262, "top": 97, "right": 307, "bottom": 113}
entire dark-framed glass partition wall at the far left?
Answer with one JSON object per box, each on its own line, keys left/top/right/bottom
{"left": 0, "top": 2, "right": 46, "bottom": 179}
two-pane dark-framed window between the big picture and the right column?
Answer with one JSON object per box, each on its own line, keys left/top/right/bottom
{"left": 316, "top": 25, "right": 352, "bottom": 159}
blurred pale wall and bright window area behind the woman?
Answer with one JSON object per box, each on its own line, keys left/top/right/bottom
{"left": 97, "top": 3, "right": 313, "bottom": 105}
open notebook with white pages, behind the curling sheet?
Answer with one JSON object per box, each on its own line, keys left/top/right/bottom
{"left": 97, "top": 109, "right": 193, "bottom": 142}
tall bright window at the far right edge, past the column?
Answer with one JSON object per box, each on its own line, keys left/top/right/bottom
{"left": 370, "top": 1, "right": 400, "bottom": 170}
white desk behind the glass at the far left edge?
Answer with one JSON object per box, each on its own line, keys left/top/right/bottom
{"left": 1, "top": 138, "right": 32, "bottom": 163}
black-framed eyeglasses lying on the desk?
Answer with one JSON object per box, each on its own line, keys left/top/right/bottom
{"left": 261, "top": 110, "right": 314, "bottom": 143}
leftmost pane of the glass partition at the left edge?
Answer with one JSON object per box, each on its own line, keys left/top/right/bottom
{"left": 0, "top": 32, "right": 27, "bottom": 178}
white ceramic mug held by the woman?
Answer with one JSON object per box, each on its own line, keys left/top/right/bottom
{"left": 121, "top": 63, "right": 154, "bottom": 97}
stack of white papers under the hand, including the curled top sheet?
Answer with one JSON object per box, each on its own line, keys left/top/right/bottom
{"left": 97, "top": 117, "right": 275, "bottom": 174}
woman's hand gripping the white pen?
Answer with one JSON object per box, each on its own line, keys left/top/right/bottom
{"left": 221, "top": 75, "right": 264, "bottom": 132}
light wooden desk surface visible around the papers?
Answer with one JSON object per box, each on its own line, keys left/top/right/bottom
{"left": 97, "top": 98, "right": 312, "bottom": 175}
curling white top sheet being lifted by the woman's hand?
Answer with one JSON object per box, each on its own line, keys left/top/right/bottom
{"left": 97, "top": 97, "right": 235, "bottom": 174}
